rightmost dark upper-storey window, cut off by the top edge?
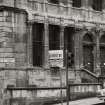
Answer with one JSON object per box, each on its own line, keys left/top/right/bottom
{"left": 92, "top": 0, "right": 103, "bottom": 11}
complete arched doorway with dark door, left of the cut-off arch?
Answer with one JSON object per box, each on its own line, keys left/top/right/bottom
{"left": 82, "top": 33, "right": 94, "bottom": 72}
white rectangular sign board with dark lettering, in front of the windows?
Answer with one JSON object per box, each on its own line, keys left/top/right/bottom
{"left": 49, "top": 50, "right": 63, "bottom": 67}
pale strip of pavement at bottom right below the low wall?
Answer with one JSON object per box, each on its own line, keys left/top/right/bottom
{"left": 54, "top": 97, "right": 104, "bottom": 105}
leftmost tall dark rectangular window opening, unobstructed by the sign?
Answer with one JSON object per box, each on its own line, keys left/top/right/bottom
{"left": 32, "top": 23, "right": 44, "bottom": 66}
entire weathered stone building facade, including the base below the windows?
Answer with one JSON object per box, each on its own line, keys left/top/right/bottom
{"left": 0, "top": 0, "right": 105, "bottom": 103}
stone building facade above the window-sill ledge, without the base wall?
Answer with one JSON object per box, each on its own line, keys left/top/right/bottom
{"left": 0, "top": 0, "right": 105, "bottom": 75}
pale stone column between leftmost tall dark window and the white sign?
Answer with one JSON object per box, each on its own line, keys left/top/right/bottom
{"left": 43, "top": 22, "right": 49, "bottom": 68}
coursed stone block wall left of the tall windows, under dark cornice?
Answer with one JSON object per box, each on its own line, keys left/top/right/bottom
{"left": 0, "top": 9, "right": 27, "bottom": 67}
